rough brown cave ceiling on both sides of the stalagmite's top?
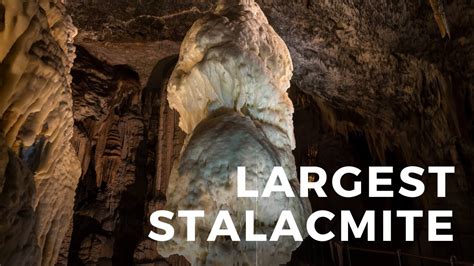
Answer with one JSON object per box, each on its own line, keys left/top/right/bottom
{"left": 66, "top": 0, "right": 474, "bottom": 162}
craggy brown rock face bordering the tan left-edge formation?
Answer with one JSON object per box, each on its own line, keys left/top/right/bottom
{"left": 64, "top": 48, "right": 143, "bottom": 264}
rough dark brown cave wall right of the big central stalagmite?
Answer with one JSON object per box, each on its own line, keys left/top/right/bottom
{"left": 267, "top": 1, "right": 474, "bottom": 265}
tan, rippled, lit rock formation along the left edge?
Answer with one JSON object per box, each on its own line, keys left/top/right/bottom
{"left": 0, "top": 0, "right": 80, "bottom": 265}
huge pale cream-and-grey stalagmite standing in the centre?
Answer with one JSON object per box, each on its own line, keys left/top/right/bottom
{"left": 158, "top": 0, "right": 310, "bottom": 265}
